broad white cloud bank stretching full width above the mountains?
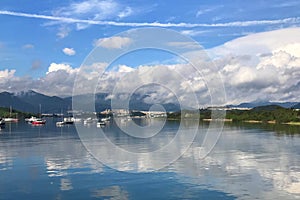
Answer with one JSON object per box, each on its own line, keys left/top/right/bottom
{"left": 0, "top": 28, "right": 300, "bottom": 106}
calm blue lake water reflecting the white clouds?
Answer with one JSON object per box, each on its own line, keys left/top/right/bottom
{"left": 0, "top": 118, "right": 300, "bottom": 199}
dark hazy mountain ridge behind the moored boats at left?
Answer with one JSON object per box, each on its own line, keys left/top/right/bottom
{"left": 0, "top": 90, "right": 180, "bottom": 113}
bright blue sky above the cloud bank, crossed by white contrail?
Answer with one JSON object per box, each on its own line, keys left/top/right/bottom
{"left": 0, "top": 0, "right": 300, "bottom": 104}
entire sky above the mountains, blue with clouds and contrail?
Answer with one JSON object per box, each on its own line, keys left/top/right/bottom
{"left": 0, "top": 0, "right": 300, "bottom": 106}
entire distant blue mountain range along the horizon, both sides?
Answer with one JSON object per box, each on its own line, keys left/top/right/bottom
{"left": 0, "top": 90, "right": 300, "bottom": 113}
